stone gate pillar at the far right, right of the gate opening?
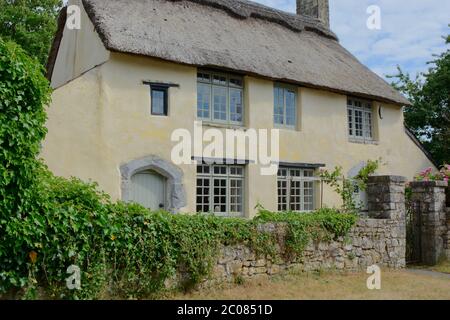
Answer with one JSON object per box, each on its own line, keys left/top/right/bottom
{"left": 411, "top": 181, "right": 448, "bottom": 265}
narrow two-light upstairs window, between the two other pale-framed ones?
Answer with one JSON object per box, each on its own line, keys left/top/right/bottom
{"left": 273, "top": 84, "right": 297, "bottom": 129}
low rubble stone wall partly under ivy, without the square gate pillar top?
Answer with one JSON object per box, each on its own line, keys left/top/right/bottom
{"left": 213, "top": 219, "right": 405, "bottom": 281}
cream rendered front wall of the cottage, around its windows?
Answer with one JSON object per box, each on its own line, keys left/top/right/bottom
{"left": 42, "top": 35, "right": 432, "bottom": 216}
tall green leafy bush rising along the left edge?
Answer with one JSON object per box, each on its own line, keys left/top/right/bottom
{"left": 0, "top": 38, "right": 50, "bottom": 296}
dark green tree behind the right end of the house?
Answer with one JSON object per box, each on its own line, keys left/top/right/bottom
{"left": 391, "top": 31, "right": 450, "bottom": 165}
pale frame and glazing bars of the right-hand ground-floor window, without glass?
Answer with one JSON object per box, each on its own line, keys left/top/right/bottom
{"left": 277, "top": 167, "right": 319, "bottom": 212}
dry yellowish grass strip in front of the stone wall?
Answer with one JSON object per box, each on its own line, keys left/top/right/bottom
{"left": 170, "top": 270, "right": 450, "bottom": 300}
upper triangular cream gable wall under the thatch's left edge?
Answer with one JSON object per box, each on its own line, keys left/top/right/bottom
{"left": 51, "top": 0, "right": 109, "bottom": 88}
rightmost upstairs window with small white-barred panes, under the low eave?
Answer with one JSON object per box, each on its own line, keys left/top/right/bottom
{"left": 347, "top": 98, "right": 373, "bottom": 141}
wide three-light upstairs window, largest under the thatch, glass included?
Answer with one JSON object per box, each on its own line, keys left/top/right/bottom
{"left": 197, "top": 71, "right": 244, "bottom": 125}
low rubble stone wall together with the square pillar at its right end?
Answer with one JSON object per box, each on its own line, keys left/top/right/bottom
{"left": 207, "top": 176, "right": 406, "bottom": 282}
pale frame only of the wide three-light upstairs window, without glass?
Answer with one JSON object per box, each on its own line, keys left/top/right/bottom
{"left": 196, "top": 70, "right": 245, "bottom": 126}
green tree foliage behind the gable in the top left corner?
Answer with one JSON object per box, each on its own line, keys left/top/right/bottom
{"left": 0, "top": 0, "right": 62, "bottom": 65}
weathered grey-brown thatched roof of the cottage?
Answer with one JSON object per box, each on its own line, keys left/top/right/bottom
{"left": 51, "top": 0, "right": 409, "bottom": 104}
